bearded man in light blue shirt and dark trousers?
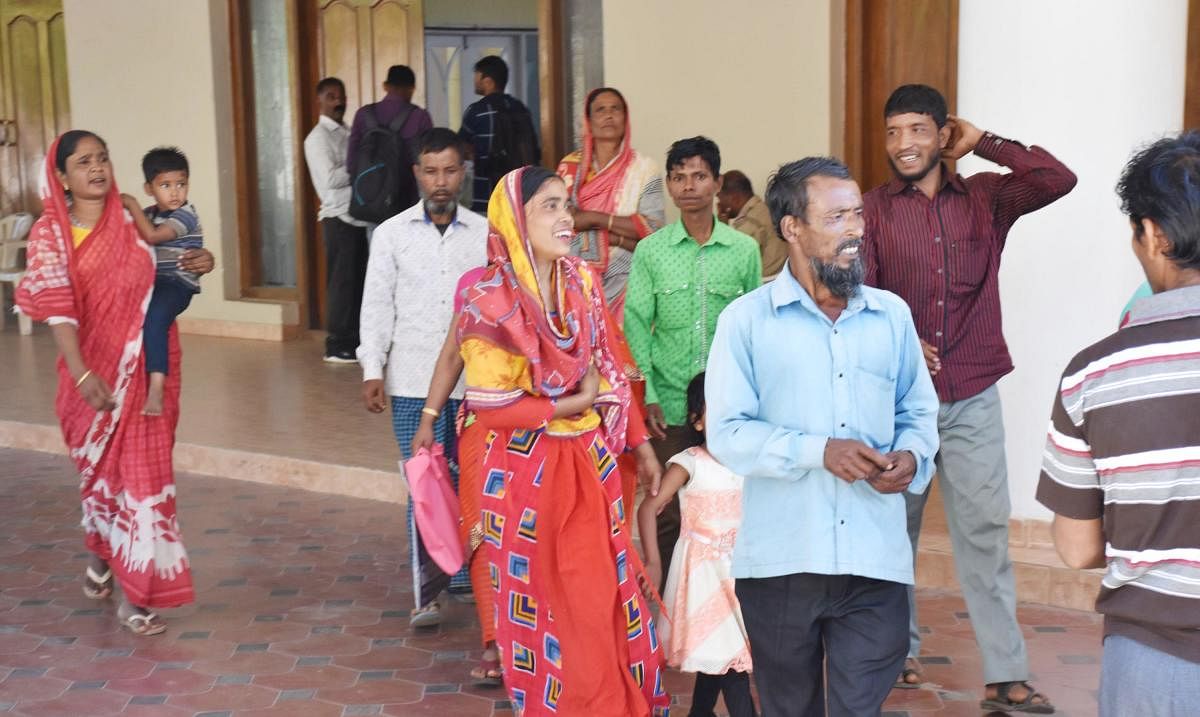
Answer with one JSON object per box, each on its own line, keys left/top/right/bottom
{"left": 706, "top": 157, "right": 938, "bottom": 717}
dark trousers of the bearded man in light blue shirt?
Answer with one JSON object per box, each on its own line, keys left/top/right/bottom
{"left": 736, "top": 573, "right": 908, "bottom": 717}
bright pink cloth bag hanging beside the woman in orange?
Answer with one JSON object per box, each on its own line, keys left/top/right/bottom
{"left": 401, "top": 444, "right": 463, "bottom": 576}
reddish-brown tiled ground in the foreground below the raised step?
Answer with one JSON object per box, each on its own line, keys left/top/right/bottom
{"left": 0, "top": 450, "right": 1099, "bottom": 717}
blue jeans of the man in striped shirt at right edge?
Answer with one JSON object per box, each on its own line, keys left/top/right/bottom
{"left": 1100, "top": 634, "right": 1200, "bottom": 717}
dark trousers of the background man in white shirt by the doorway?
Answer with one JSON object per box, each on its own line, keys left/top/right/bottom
{"left": 320, "top": 218, "right": 370, "bottom": 354}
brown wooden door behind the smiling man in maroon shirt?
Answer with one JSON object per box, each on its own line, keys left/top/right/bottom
{"left": 844, "top": 0, "right": 959, "bottom": 192}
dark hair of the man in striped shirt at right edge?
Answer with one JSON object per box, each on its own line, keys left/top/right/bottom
{"left": 1117, "top": 129, "right": 1200, "bottom": 271}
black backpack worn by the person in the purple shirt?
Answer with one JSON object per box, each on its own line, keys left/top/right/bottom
{"left": 350, "top": 106, "right": 419, "bottom": 224}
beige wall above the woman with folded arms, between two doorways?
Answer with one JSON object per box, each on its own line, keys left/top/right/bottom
{"left": 604, "top": 0, "right": 841, "bottom": 211}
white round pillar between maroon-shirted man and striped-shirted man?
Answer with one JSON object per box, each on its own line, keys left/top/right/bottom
{"left": 958, "top": 0, "right": 1187, "bottom": 518}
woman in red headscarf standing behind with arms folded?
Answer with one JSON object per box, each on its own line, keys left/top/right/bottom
{"left": 558, "top": 88, "right": 666, "bottom": 325}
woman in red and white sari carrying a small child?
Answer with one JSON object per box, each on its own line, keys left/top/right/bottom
{"left": 17, "top": 129, "right": 212, "bottom": 634}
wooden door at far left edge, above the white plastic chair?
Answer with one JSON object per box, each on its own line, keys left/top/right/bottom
{"left": 0, "top": 0, "right": 71, "bottom": 215}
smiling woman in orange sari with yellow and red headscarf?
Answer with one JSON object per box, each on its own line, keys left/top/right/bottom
{"left": 458, "top": 167, "right": 670, "bottom": 717}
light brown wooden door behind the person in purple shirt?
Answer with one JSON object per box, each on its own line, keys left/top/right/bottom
{"left": 302, "top": 0, "right": 425, "bottom": 326}
